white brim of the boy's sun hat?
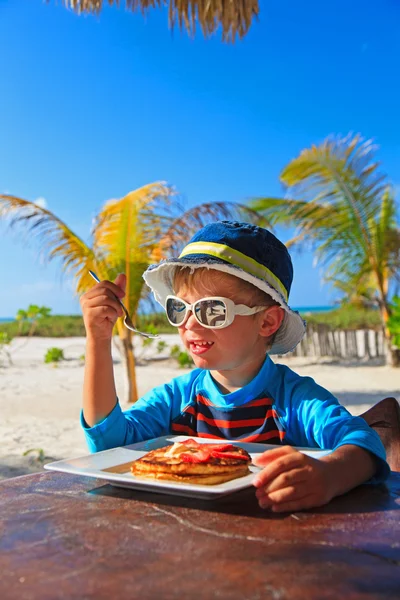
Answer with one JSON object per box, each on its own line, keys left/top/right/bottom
{"left": 143, "top": 257, "right": 306, "bottom": 354}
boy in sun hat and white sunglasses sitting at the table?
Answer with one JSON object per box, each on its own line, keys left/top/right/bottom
{"left": 81, "top": 221, "right": 390, "bottom": 512}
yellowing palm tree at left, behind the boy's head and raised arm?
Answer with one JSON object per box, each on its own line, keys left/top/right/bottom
{"left": 0, "top": 182, "right": 259, "bottom": 402}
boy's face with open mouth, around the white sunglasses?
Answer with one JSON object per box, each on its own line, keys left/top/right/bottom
{"left": 175, "top": 271, "right": 283, "bottom": 372}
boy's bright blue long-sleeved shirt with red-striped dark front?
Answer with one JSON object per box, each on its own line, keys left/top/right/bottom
{"left": 81, "top": 356, "right": 390, "bottom": 482}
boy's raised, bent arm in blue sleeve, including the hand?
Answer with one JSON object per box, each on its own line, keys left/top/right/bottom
{"left": 81, "top": 275, "right": 197, "bottom": 452}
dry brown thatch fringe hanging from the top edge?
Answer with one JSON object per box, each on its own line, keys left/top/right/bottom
{"left": 59, "top": 0, "right": 259, "bottom": 41}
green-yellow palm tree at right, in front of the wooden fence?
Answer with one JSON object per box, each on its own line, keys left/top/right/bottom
{"left": 250, "top": 134, "right": 400, "bottom": 364}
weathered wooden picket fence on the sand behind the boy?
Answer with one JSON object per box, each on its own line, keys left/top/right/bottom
{"left": 291, "top": 325, "right": 385, "bottom": 358}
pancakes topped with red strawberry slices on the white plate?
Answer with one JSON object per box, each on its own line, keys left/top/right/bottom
{"left": 131, "top": 439, "right": 251, "bottom": 485}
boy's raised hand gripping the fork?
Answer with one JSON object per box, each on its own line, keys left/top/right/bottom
{"left": 80, "top": 274, "right": 126, "bottom": 340}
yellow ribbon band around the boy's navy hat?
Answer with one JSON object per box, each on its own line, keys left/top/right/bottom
{"left": 179, "top": 242, "right": 289, "bottom": 302}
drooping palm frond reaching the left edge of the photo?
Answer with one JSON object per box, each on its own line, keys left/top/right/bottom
{"left": 0, "top": 194, "right": 98, "bottom": 292}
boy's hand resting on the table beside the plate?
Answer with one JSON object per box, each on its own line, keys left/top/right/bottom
{"left": 253, "top": 446, "right": 335, "bottom": 512}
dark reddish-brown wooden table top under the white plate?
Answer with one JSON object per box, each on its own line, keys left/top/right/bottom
{"left": 0, "top": 472, "right": 400, "bottom": 600}
